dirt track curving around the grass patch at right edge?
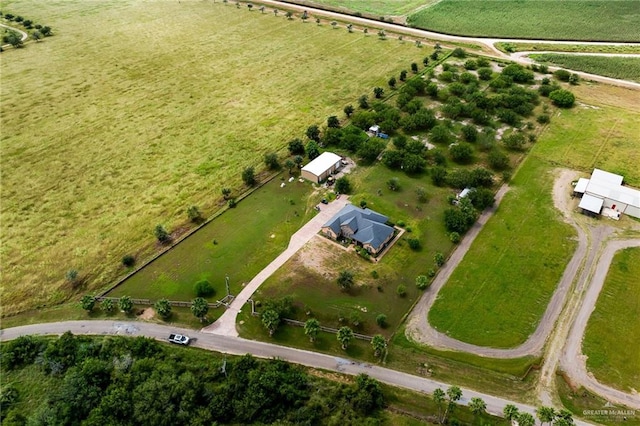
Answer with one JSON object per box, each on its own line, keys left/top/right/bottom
{"left": 560, "top": 239, "right": 640, "bottom": 410}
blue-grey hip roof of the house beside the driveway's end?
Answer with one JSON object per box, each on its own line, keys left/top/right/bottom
{"left": 323, "top": 204, "right": 393, "bottom": 249}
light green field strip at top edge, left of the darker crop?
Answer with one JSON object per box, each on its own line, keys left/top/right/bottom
{"left": 293, "top": 0, "right": 438, "bottom": 16}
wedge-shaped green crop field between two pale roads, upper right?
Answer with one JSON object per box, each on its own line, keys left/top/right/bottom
{"left": 531, "top": 53, "right": 640, "bottom": 82}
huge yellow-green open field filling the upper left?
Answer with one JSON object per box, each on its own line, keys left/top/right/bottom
{"left": 0, "top": 1, "right": 430, "bottom": 314}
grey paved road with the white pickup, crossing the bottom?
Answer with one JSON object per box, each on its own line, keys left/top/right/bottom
{"left": 0, "top": 321, "right": 589, "bottom": 425}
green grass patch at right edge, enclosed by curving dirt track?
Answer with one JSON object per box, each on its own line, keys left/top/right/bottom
{"left": 582, "top": 248, "right": 640, "bottom": 392}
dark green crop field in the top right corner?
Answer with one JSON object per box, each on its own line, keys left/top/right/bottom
{"left": 408, "top": 0, "right": 640, "bottom": 41}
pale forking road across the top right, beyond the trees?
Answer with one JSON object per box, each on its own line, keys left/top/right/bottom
{"left": 252, "top": 0, "right": 640, "bottom": 90}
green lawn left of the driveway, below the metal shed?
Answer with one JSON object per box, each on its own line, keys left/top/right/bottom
{"left": 109, "top": 178, "right": 317, "bottom": 301}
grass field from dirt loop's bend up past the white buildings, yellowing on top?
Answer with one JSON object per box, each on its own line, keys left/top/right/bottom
{"left": 429, "top": 84, "right": 640, "bottom": 347}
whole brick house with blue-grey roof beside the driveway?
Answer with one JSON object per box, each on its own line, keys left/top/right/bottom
{"left": 322, "top": 204, "right": 395, "bottom": 256}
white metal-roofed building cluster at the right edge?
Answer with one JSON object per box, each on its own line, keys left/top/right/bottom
{"left": 573, "top": 169, "right": 640, "bottom": 218}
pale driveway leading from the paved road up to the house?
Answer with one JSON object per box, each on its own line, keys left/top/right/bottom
{"left": 202, "top": 195, "right": 349, "bottom": 336}
